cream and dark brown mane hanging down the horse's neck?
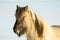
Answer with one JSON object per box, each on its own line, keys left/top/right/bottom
{"left": 30, "top": 10, "right": 43, "bottom": 37}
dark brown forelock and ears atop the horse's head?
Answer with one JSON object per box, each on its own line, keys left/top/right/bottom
{"left": 15, "top": 5, "right": 29, "bottom": 18}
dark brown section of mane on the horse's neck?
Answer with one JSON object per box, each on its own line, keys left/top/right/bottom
{"left": 35, "top": 14, "right": 43, "bottom": 36}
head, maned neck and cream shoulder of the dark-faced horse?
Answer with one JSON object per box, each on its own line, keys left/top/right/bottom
{"left": 13, "top": 5, "right": 58, "bottom": 40}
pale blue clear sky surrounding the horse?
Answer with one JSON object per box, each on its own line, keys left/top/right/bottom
{"left": 0, "top": 0, "right": 60, "bottom": 40}
